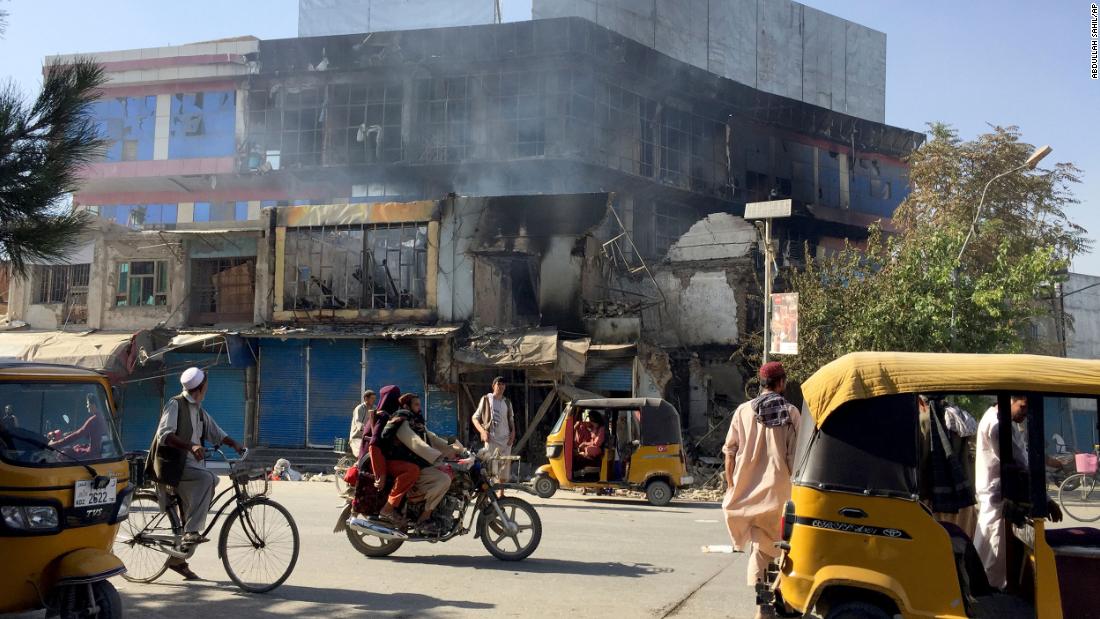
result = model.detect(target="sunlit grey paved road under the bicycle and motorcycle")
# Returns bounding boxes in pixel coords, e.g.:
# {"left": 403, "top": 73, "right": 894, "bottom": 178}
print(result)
{"left": 90, "top": 483, "right": 755, "bottom": 619}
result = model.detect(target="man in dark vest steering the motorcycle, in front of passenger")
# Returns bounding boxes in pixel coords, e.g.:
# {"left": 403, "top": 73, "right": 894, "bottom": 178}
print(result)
{"left": 381, "top": 394, "right": 460, "bottom": 532}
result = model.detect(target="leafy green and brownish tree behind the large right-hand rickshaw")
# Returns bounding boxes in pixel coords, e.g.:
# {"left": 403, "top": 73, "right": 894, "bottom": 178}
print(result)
{"left": 784, "top": 124, "right": 1089, "bottom": 379}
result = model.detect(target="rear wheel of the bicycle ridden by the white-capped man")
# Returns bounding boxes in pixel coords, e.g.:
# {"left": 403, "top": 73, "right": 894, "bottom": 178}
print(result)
{"left": 113, "top": 491, "right": 174, "bottom": 583}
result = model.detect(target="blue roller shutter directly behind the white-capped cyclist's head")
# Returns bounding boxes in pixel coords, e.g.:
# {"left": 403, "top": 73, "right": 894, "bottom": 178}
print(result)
{"left": 164, "top": 353, "right": 246, "bottom": 443}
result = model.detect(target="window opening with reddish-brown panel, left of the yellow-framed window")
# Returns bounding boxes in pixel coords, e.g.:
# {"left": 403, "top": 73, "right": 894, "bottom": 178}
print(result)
{"left": 190, "top": 257, "right": 256, "bottom": 324}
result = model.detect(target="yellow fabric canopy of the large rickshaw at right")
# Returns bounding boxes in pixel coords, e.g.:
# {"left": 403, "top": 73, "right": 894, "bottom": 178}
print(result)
{"left": 802, "top": 352, "right": 1100, "bottom": 428}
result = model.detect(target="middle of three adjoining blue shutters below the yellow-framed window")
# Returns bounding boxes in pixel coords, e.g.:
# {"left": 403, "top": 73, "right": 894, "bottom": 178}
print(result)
{"left": 308, "top": 340, "right": 363, "bottom": 447}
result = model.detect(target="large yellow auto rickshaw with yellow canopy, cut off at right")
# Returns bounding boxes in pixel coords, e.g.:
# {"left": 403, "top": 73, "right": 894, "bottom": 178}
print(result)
{"left": 757, "top": 353, "right": 1100, "bottom": 619}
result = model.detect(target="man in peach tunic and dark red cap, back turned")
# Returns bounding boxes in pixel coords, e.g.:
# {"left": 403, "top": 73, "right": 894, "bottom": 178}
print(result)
{"left": 722, "top": 362, "right": 800, "bottom": 617}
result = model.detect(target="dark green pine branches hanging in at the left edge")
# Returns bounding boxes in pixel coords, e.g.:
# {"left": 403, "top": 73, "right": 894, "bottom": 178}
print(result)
{"left": 0, "top": 59, "right": 106, "bottom": 275}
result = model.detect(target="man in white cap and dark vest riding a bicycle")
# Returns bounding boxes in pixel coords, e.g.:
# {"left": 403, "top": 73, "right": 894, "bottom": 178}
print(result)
{"left": 156, "top": 367, "right": 244, "bottom": 581}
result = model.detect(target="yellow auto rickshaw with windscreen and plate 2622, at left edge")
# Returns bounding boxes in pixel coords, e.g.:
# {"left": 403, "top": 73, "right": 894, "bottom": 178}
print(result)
{"left": 0, "top": 363, "right": 131, "bottom": 618}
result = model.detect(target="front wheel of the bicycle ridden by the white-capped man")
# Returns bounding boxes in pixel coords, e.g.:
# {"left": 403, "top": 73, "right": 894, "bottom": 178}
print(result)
{"left": 218, "top": 498, "right": 299, "bottom": 594}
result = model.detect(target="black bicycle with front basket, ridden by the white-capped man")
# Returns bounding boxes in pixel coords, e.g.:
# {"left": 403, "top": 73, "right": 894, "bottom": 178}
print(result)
{"left": 114, "top": 450, "right": 300, "bottom": 594}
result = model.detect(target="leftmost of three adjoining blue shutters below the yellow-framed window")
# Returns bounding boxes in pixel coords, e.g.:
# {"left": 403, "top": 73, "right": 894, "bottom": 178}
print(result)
{"left": 259, "top": 339, "right": 308, "bottom": 447}
